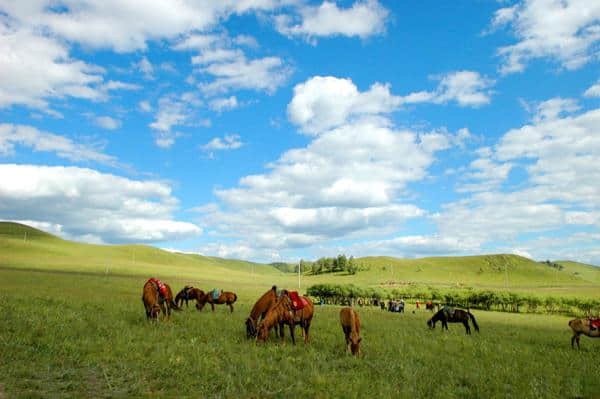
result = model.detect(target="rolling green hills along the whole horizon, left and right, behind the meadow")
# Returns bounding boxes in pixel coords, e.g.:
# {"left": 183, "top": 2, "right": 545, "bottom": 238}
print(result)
{"left": 0, "top": 222, "right": 600, "bottom": 296}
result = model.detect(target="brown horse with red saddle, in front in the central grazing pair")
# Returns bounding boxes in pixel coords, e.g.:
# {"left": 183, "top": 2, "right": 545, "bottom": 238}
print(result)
{"left": 256, "top": 290, "right": 314, "bottom": 345}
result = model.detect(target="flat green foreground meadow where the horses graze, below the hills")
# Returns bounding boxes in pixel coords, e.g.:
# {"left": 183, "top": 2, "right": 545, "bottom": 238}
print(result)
{"left": 0, "top": 269, "right": 600, "bottom": 398}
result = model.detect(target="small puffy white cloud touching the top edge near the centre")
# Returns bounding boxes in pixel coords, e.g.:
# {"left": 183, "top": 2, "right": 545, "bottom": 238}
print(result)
{"left": 275, "top": 0, "right": 389, "bottom": 40}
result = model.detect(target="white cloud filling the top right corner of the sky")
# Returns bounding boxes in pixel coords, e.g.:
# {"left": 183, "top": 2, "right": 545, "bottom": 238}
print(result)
{"left": 492, "top": 0, "right": 600, "bottom": 73}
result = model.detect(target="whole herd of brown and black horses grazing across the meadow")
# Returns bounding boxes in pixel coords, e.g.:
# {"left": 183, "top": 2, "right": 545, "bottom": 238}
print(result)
{"left": 142, "top": 279, "right": 600, "bottom": 355}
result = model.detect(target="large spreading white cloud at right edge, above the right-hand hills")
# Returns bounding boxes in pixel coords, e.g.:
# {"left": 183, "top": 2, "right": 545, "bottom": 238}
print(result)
{"left": 432, "top": 99, "right": 600, "bottom": 259}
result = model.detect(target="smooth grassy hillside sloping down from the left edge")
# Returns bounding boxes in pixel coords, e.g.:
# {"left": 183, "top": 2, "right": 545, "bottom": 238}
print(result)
{"left": 0, "top": 222, "right": 282, "bottom": 281}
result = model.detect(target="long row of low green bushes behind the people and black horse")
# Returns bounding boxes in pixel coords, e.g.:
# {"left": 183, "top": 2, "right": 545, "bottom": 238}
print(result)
{"left": 307, "top": 284, "right": 600, "bottom": 316}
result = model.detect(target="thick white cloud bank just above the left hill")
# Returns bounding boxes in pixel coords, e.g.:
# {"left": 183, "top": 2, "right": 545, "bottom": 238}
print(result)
{"left": 0, "top": 164, "right": 202, "bottom": 242}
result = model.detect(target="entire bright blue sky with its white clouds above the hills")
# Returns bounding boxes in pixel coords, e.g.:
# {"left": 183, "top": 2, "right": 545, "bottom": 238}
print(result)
{"left": 0, "top": 0, "right": 600, "bottom": 264}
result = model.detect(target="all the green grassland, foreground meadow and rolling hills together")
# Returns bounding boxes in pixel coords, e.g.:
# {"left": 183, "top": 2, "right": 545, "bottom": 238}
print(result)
{"left": 0, "top": 223, "right": 600, "bottom": 398}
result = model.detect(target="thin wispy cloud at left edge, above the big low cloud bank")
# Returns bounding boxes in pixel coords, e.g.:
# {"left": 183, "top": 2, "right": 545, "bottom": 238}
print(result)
{"left": 0, "top": 123, "right": 120, "bottom": 167}
